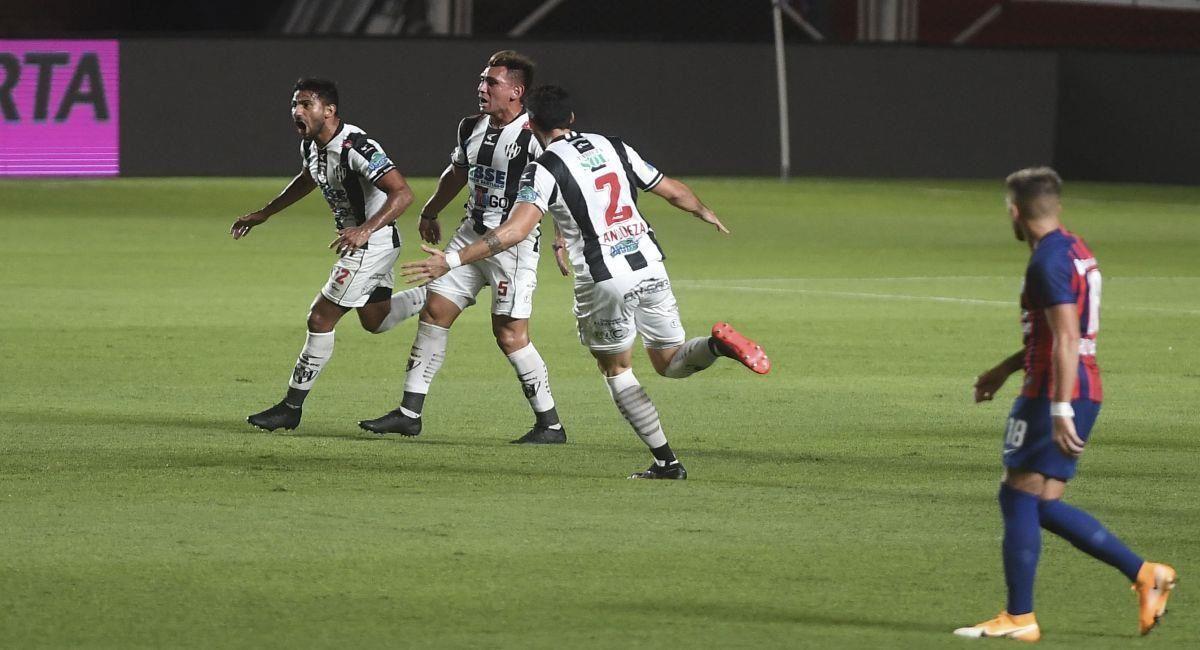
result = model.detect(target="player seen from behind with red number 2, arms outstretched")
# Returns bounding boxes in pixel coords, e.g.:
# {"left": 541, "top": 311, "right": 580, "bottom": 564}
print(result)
{"left": 393, "top": 86, "right": 770, "bottom": 479}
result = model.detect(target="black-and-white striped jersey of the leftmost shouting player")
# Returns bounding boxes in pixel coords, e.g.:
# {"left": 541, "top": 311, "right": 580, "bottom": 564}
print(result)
{"left": 300, "top": 122, "right": 400, "bottom": 248}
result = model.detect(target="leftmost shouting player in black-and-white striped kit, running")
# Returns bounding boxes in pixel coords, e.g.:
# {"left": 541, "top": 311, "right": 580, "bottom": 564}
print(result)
{"left": 229, "top": 78, "right": 425, "bottom": 431}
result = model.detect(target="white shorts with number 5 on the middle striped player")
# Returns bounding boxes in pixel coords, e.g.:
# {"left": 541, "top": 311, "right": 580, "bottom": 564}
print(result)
{"left": 428, "top": 222, "right": 539, "bottom": 319}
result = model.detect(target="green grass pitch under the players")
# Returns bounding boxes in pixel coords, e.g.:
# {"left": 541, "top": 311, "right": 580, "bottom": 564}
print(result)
{"left": 0, "top": 179, "right": 1200, "bottom": 649}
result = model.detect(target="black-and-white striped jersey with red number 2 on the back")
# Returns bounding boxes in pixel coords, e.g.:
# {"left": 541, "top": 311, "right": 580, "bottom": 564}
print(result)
{"left": 516, "top": 131, "right": 664, "bottom": 282}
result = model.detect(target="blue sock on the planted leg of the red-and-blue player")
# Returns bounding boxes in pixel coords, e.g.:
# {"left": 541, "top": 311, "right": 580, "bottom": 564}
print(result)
{"left": 1000, "top": 485, "right": 1042, "bottom": 615}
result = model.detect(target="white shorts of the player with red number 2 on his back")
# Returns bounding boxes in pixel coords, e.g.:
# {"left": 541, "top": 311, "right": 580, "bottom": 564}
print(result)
{"left": 575, "top": 263, "right": 684, "bottom": 353}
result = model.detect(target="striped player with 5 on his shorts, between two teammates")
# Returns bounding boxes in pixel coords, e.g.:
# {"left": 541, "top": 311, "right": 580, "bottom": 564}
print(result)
{"left": 359, "top": 50, "right": 568, "bottom": 444}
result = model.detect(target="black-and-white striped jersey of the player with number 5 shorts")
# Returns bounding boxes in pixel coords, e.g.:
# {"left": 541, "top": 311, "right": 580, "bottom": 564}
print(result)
{"left": 450, "top": 110, "right": 541, "bottom": 235}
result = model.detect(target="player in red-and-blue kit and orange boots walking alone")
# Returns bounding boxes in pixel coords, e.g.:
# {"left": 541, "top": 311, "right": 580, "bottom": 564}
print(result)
{"left": 954, "top": 167, "right": 1175, "bottom": 642}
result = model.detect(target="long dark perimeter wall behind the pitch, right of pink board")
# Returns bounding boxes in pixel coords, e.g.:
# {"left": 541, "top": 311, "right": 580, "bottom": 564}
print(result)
{"left": 120, "top": 38, "right": 1200, "bottom": 183}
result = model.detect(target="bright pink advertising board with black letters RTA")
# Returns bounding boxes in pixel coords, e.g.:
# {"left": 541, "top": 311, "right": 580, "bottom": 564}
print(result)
{"left": 0, "top": 40, "right": 120, "bottom": 176}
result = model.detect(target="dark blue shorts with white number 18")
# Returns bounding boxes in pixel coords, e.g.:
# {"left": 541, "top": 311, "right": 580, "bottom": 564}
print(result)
{"left": 1003, "top": 396, "right": 1100, "bottom": 481}
